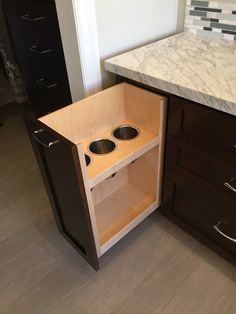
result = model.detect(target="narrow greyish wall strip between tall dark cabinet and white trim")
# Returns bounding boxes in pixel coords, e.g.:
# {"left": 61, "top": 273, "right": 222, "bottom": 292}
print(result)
{"left": 56, "top": 0, "right": 84, "bottom": 102}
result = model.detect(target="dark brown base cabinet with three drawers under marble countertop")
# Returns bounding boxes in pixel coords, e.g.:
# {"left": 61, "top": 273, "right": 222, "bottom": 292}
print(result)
{"left": 161, "top": 96, "right": 236, "bottom": 264}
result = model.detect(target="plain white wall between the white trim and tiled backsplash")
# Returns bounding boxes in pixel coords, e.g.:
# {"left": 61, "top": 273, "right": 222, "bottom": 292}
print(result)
{"left": 95, "top": 0, "right": 182, "bottom": 87}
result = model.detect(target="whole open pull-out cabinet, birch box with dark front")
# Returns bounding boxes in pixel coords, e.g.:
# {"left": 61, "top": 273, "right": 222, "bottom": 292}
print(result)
{"left": 26, "top": 83, "right": 166, "bottom": 269}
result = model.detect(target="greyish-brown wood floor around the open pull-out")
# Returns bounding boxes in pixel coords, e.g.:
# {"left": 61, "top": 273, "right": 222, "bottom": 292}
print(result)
{"left": 0, "top": 116, "right": 236, "bottom": 314}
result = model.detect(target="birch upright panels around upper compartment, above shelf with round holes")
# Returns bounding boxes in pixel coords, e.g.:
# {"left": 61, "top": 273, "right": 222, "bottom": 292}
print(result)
{"left": 39, "top": 83, "right": 164, "bottom": 144}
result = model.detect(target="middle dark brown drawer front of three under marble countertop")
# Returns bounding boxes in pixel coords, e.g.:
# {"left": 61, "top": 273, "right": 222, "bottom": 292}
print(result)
{"left": 166, "top": 138, "right": 236, "bottom": 203}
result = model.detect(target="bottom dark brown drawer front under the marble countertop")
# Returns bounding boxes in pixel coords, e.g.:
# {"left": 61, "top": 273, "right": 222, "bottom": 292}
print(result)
{"left": 162, "top": 171, "right": 236, "bottom": 262}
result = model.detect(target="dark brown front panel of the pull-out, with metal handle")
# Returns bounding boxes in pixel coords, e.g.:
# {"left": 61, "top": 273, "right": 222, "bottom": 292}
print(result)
{"left": 24, "top": 116, "right": 99, "bottom": 270}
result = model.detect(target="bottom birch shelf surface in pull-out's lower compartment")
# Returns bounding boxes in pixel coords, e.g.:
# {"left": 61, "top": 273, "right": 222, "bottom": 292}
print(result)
{"left": 95, "top": 183, "right": 155, "bottom": 246}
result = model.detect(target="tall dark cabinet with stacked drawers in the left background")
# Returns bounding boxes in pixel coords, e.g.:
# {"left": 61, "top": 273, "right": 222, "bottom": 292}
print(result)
{"left": 3, "top": 0, "right": 72, "bottom": 117}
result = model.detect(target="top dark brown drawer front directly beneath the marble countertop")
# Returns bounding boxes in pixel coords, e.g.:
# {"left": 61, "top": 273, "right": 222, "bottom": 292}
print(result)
{"left": 168, "top": 96, "right": 236, "bottom": 163}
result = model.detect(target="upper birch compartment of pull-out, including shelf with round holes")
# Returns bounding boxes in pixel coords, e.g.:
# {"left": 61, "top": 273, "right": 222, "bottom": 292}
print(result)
{"left": 40, "top": 83, "right": 164, "bottom": 188}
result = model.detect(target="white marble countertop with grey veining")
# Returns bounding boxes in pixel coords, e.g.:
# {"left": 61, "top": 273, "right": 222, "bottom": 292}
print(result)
{"left": 105, "top": 33, "right": 236, "bottom": 116}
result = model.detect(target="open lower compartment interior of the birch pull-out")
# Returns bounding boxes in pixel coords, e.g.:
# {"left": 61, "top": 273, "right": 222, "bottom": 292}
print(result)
{"left": 92, "top": 147, "right": 158, "bottom": 246}
